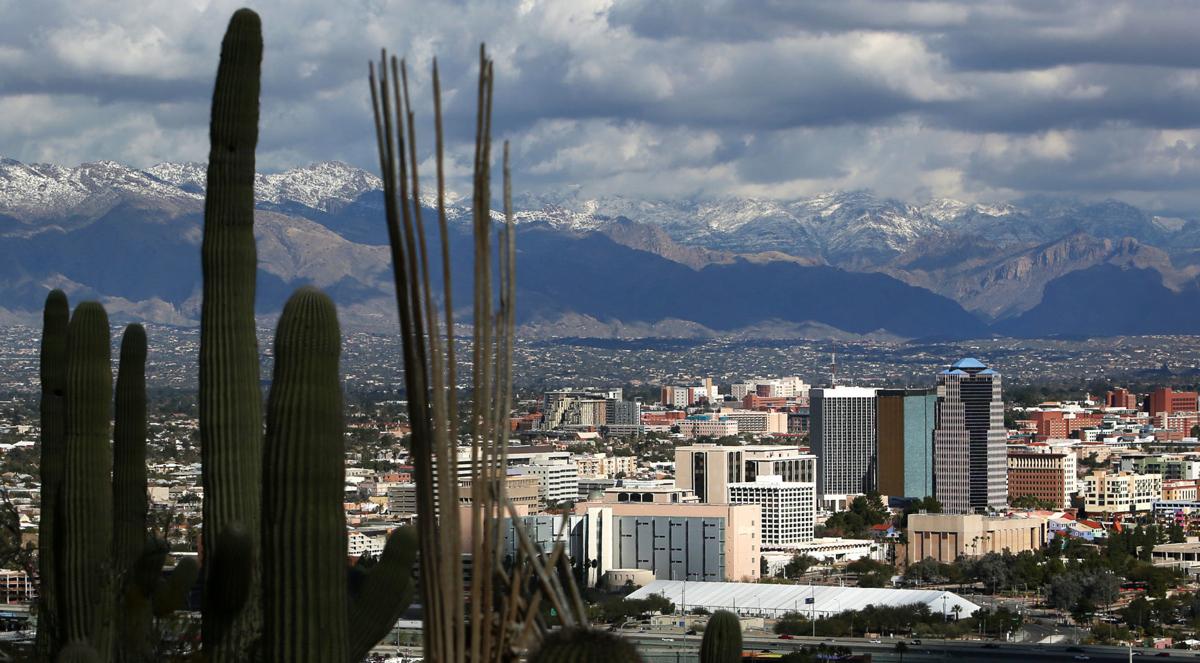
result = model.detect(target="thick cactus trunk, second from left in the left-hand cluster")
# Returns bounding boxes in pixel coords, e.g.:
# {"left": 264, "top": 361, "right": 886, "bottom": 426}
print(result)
{"left": 59, "top": 301, "right": 114, "bottom": 658}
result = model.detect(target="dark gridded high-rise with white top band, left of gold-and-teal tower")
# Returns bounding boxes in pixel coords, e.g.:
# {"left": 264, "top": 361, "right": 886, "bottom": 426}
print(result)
{"left": 809, "top": 387, "right": 877, "bottom": 500}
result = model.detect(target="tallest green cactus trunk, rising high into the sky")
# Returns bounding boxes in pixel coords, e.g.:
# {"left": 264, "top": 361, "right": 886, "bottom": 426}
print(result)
{"left": 199, "top": 10, "right": 263, "bottom": 663}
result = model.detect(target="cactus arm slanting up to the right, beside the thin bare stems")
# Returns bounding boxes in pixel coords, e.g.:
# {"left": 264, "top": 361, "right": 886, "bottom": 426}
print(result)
{"left": 347, "top": 527, "right": 416, "bottom": 663}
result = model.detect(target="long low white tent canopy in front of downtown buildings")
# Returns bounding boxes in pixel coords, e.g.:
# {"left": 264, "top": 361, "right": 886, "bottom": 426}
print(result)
{"left": 629, "top": 580, "right": 979, "bottom": 619}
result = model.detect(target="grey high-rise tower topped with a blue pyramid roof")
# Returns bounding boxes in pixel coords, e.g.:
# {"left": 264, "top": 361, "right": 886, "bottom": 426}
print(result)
{"left": 934, "top": 358, "right": 1008, "bottom": 513}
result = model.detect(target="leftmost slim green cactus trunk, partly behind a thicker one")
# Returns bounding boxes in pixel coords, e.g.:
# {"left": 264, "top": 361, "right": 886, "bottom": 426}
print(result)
{"left": 36, "top": 289, "right": 71, "bottom": 661}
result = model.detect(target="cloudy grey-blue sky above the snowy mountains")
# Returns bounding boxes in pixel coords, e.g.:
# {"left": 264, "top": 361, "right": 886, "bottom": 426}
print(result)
{"left": 0, "top": 0, "right": 1200, "bottom": 216}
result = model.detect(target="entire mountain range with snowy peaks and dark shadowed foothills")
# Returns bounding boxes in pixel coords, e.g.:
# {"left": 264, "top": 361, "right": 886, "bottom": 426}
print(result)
{"left": 0, "top": 159, "right": 1200, "bottom": 339}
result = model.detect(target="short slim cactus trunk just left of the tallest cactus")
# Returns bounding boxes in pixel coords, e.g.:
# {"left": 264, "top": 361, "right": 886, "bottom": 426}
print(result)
{"left": 113, "top": 324, "right": 147, "bottom": 574}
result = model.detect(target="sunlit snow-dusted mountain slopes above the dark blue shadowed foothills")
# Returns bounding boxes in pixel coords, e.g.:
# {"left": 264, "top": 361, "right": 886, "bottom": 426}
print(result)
{"left": 0, "top": 160, "right": 1200, "bottom": 336}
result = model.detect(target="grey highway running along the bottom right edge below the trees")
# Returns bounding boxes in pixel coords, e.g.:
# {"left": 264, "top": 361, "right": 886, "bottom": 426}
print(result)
{"left": 624, "top": 633, "right": 1200, "bottom": 663}
